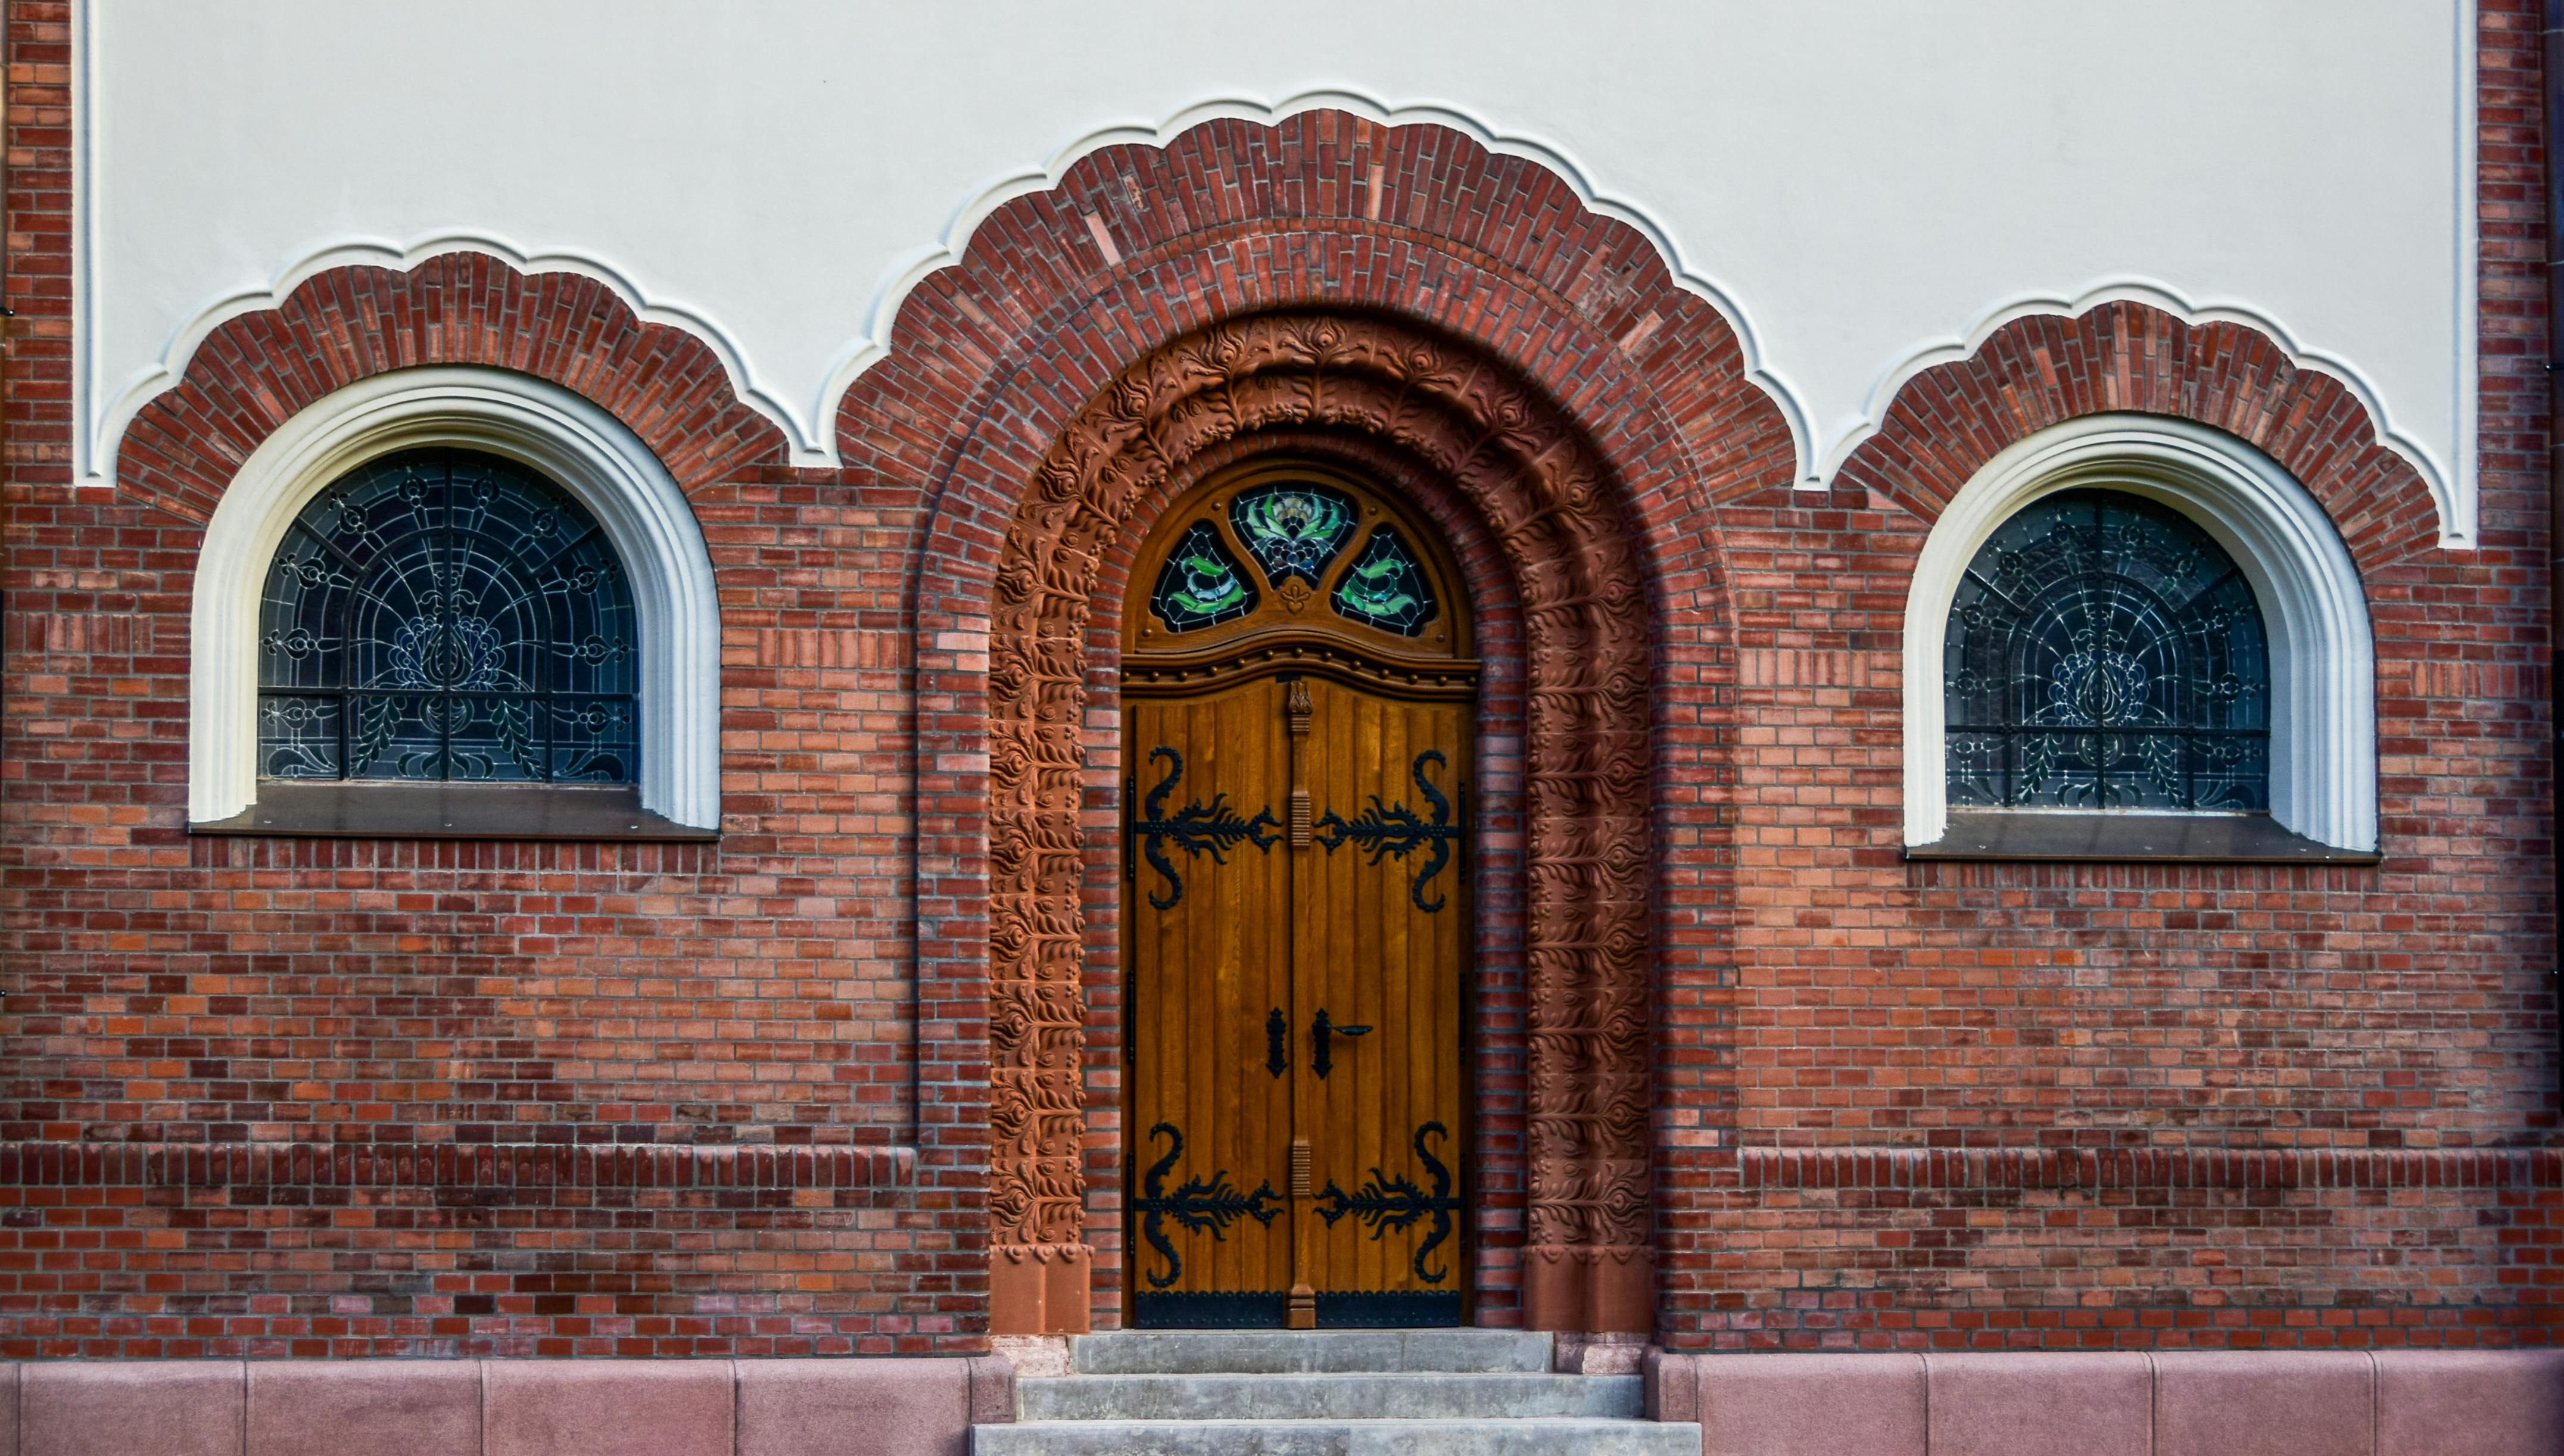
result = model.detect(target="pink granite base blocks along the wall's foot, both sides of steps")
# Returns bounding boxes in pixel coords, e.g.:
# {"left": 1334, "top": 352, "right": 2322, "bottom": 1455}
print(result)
{"left": 0, "top": 1351, "right": 2564, "bottom": 1456}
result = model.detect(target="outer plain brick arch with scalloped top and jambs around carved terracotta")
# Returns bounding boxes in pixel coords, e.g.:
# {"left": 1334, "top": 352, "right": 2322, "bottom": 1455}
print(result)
{"left": 839, "top": 110, "right": 1795, "bottom": 1333}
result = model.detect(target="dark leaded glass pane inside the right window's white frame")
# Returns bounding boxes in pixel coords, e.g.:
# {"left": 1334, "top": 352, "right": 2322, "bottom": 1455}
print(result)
{"left": 1943, "top": 490, "right": 2269, "bottom": 813}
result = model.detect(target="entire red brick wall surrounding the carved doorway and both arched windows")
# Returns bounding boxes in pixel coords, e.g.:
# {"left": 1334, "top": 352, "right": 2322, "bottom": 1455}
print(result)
{"left": 0, "top": 0, "right": 2564, "bottom": 1356}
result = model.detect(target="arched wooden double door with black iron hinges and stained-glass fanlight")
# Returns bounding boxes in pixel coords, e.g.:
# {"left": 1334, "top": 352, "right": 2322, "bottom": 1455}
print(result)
{"left": 1123, "top": 459, "right": 1477, "bottom": 1328}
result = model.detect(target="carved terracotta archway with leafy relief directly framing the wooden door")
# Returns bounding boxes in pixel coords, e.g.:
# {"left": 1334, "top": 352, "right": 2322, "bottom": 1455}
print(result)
{"left": 987, "top": 313, "right": 1654, "bottom": 1333}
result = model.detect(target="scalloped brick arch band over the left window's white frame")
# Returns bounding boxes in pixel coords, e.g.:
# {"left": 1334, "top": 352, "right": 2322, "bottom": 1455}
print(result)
{"left": 116, "top": 254, "right": 787, "bottom": 520}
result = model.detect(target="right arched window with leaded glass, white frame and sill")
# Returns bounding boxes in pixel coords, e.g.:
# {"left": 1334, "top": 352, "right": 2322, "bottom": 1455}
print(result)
{"left": 1905, "top": 413, "right": 2377, "bottom": 861}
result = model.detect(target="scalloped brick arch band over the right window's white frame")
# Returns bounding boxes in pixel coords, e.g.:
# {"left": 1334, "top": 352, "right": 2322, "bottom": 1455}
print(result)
{"left": 1836, "top": 303, "right": 2438, "bottom": 572}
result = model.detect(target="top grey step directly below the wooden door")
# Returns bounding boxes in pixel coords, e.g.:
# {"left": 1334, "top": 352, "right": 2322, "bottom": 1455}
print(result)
{"left": 1069, "top": 1330, "right": 1552, "bottom": 1374}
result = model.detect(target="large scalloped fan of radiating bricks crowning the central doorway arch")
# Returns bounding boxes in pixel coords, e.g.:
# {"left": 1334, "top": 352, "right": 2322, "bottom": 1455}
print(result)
{"left": 836, "top": 110, "right": 1795, "bottom": 538}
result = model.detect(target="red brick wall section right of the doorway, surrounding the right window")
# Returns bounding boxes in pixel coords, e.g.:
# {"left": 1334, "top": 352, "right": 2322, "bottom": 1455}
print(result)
{"left": 1659, "top": 5, "right": 2564, "bottom": 1348}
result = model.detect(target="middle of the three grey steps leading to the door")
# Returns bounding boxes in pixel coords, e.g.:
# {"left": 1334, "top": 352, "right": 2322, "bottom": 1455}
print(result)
{"left": 1015, "top": 1371, "right": 1646, "bottom": 1420}
